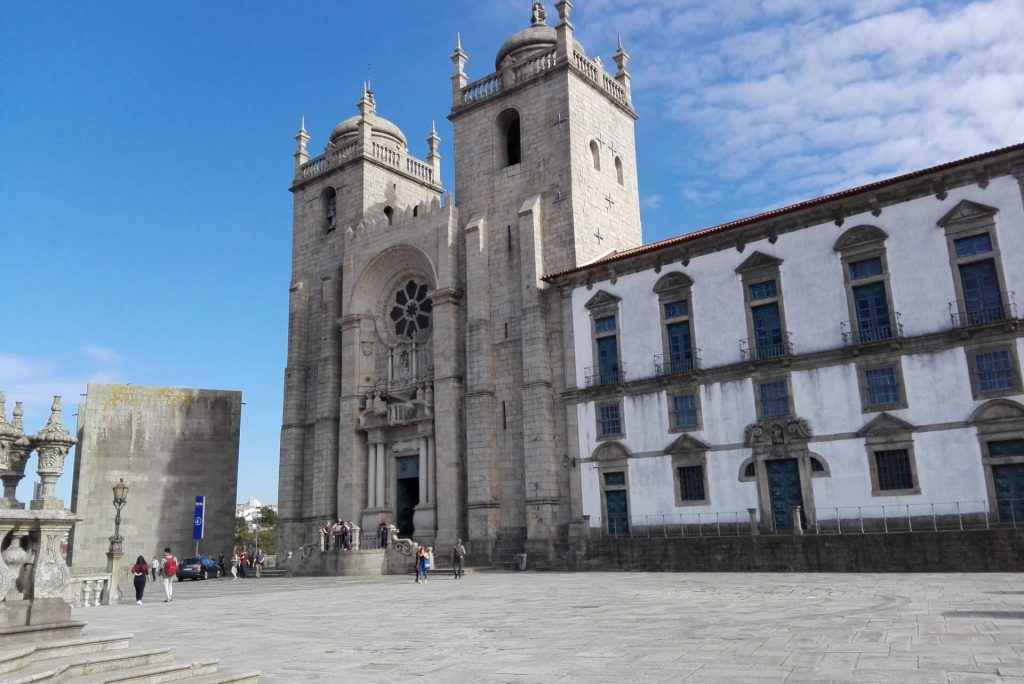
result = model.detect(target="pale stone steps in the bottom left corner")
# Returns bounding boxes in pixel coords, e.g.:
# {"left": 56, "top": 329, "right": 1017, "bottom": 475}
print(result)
{"left": 0, "top": 622, "right": 259, "bottom": 684}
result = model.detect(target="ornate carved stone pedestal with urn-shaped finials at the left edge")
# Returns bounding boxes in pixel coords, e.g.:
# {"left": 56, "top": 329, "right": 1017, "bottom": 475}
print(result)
{"left": 0, "top": 392, "right": 79, "bottom": 628}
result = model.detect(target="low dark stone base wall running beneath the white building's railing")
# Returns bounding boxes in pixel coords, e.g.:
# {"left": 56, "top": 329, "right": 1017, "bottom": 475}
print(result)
{"left": 552, "top": 528, "right": 1024, "bottom": 572}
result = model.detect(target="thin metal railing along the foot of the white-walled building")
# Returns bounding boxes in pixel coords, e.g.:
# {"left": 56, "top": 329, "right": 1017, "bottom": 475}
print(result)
{"left": 589, "top": 499, "right": 1024, "bottom": 539}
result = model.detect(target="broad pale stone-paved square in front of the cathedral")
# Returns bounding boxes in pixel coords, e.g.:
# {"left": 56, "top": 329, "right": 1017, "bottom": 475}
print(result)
{"left": 76, "top": 572, "right": 1024, "bottom": 684}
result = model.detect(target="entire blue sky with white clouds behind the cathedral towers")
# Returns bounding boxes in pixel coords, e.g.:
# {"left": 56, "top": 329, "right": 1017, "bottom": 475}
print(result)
{"left": 0, "top": 0, "right": 1024, "bottom": 502}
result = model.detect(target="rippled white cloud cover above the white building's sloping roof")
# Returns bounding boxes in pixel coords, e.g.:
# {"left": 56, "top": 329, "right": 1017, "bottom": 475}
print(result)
{"left": 577, "top": 0, "right": 1024, "bottom": 214}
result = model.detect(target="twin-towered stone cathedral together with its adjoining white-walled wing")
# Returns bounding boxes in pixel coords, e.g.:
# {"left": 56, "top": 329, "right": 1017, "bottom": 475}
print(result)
{"left": 279, "top": 0, "right": 1024, "bottom": 566}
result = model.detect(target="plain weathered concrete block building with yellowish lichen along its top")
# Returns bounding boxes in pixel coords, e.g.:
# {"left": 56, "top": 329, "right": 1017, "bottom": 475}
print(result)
{"left": 69, "top": 383, "right": 242, "bottom": 571}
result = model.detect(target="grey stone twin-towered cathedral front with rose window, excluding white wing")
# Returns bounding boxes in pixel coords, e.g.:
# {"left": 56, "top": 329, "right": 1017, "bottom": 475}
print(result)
{"left": 279, "top": 0, "right": 641, "bottom": 558}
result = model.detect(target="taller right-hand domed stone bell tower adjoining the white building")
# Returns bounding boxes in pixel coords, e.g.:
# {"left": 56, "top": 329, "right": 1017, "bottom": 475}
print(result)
{"left": 449, "top": 0, "right": 641, "bottom": 562}
